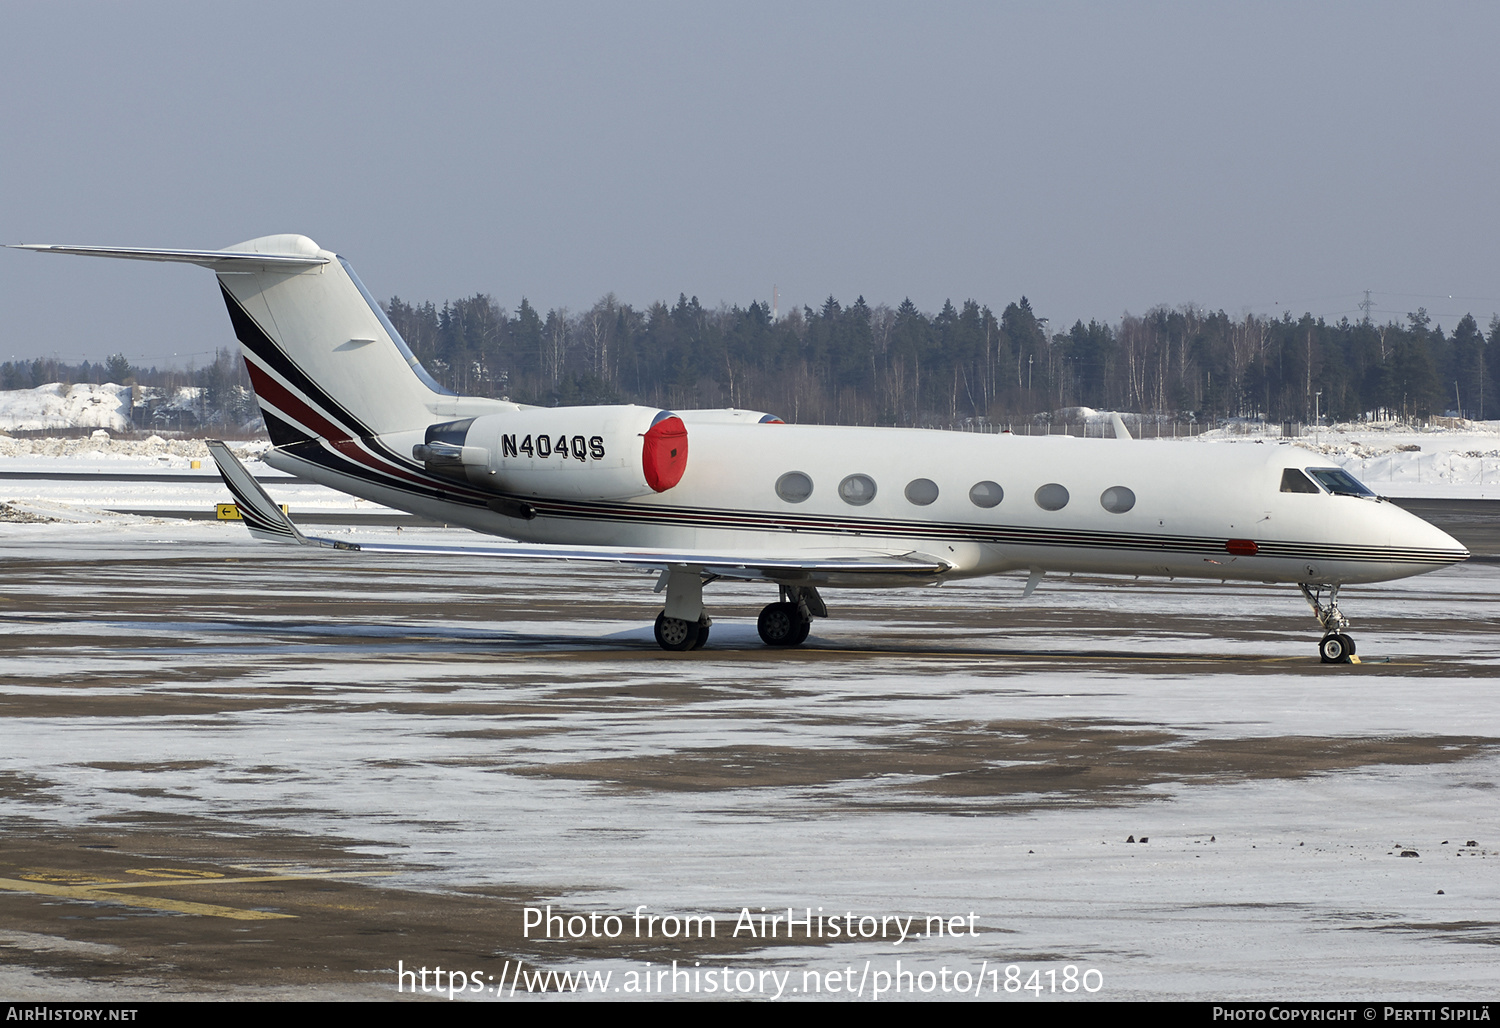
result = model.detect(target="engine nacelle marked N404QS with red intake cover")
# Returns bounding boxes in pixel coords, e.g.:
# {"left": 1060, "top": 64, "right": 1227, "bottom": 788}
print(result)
{"left": 411, "top": 404, "right": 687, "bottom": 500}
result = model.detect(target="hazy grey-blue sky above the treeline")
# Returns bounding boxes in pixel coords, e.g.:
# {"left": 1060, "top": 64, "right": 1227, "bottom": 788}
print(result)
{"left": 0, "top": 0, "right": 1500, "bottom": 366}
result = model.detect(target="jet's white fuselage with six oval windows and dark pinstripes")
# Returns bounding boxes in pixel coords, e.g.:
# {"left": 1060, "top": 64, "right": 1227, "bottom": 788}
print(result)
{"left": 267, "top": 413, "right": 1467, "bottom": 585}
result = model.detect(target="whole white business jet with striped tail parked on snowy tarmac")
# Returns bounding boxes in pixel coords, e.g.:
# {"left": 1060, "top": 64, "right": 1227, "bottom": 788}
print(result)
{"left": 8, "top": 236, "right": 1469, "bottom": 663}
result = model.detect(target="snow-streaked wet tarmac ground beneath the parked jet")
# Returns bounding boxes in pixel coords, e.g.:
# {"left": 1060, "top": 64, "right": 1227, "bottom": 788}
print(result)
{"left": 0, "top": 518, "right": 1500, "bottom": 1001}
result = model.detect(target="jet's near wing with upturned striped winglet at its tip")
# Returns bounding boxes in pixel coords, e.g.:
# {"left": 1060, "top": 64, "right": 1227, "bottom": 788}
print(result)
{"left": 209, "top": 440, "right": 951, "bottom": 584}
